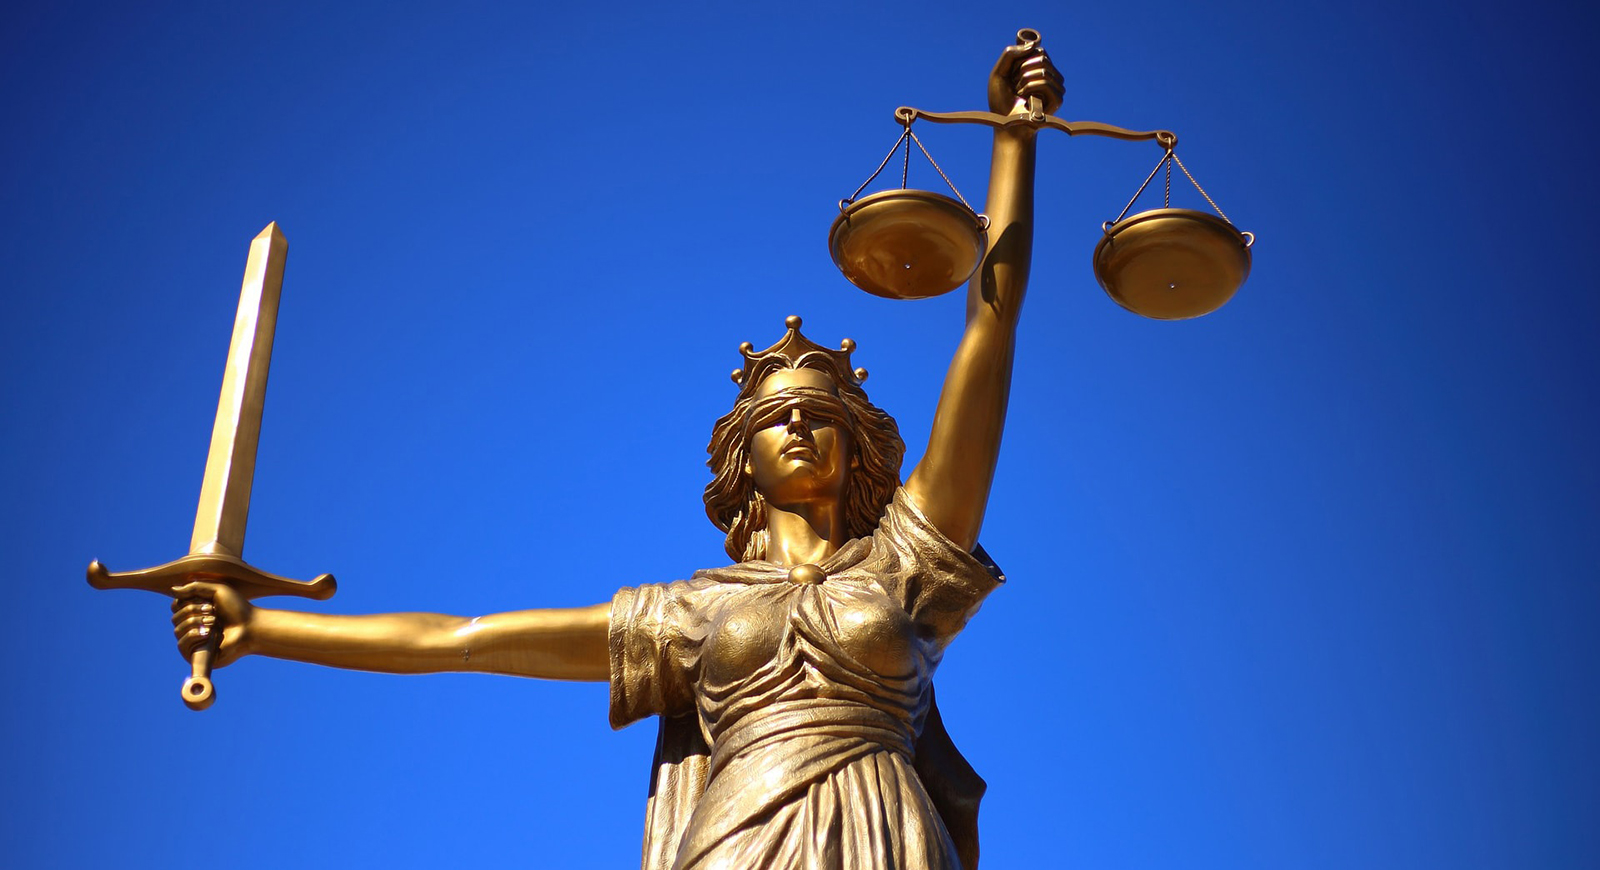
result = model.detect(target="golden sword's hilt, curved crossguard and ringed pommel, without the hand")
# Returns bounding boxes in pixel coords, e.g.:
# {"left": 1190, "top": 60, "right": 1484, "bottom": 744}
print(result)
{"left": 88, "top": 553, "right": 338, "bottom": 710}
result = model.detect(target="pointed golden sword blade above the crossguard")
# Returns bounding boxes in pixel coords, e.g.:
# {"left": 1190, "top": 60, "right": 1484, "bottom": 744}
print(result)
{"left": 189, "top": 222, "right": 290, "bottom": 557}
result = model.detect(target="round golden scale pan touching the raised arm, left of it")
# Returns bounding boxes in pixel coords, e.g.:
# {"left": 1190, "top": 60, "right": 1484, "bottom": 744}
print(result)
{"left": 827, "top": 190, "right": 989, "bottom": 299}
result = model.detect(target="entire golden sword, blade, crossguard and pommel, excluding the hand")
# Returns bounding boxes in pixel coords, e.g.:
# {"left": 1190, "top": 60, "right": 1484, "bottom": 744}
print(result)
{"left": 88, "top": 222, "right": 334, "bottom": 710}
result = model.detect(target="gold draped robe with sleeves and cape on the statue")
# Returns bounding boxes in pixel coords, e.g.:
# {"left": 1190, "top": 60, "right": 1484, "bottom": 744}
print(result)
{"left": 610, "top": 489, "right": 1003, "bottom": 870}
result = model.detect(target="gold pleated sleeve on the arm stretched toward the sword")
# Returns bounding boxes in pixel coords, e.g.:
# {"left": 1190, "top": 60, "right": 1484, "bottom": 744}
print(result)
{"left": 608, "top": 579, "right": 718, "bottom": 728}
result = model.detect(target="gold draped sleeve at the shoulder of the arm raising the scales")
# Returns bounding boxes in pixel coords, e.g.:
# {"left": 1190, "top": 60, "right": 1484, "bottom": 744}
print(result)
{"left": 862, "top": 489, "right": 1005, "bottom": 646}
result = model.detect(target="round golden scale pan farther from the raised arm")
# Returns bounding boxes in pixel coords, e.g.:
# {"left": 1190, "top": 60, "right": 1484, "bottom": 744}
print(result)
{"left": 1094, "top": 208, "right": 1254, "bottom": 320}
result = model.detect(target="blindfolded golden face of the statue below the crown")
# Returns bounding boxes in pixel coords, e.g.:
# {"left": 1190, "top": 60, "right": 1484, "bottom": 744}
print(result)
{"left": 746, "top": 368, "right": 854, "bottom": 507}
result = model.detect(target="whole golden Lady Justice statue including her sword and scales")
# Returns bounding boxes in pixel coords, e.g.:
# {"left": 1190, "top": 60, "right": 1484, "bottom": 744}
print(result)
{"left": 90, "top": 30, "right": 1253, "bottom": 870}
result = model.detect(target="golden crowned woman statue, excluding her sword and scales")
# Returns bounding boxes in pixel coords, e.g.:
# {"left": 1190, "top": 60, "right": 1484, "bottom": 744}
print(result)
{"left": 156, "top": 33, "right": 1062, "bottom": 870}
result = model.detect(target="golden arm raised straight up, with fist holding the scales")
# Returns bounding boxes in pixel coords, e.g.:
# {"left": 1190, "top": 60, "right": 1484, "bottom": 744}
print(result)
{"left": 906, "top": 43, "right": 1062, "bottom": 549}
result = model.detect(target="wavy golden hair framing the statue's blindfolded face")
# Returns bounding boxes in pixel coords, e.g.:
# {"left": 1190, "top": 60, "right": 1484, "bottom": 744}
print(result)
{"left": 706, "top": 366, "right": 906, "bottom": 561}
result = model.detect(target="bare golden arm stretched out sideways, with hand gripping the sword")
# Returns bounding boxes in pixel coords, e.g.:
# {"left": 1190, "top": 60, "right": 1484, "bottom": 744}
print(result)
{"left": 173, "top": 582, "right": 610, "bottom": 681}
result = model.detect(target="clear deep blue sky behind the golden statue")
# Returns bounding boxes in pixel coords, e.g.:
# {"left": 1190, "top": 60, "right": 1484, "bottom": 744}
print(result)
{"left": 0, "top": 0, "right": 1600, "bottom": 868}
